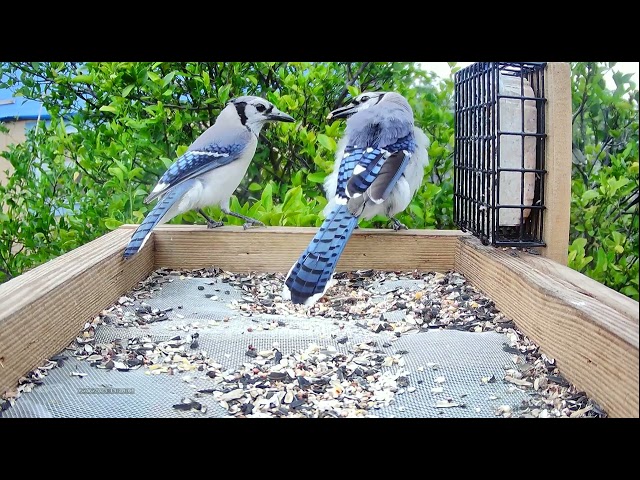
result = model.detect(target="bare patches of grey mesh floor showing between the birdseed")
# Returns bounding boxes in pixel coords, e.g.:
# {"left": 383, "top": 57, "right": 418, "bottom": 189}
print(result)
{"left": 2, "top": 278, "right": 532, "bottom": 418}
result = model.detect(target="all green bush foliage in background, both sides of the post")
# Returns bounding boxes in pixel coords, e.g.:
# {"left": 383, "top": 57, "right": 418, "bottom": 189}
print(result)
{"left": 0, "top": 62, "right": 638, "bottom": 300}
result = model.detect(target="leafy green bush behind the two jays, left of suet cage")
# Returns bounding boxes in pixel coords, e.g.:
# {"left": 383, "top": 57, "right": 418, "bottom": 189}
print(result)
{"left": 0, "top": 62, "right": 453, "bottom": 281}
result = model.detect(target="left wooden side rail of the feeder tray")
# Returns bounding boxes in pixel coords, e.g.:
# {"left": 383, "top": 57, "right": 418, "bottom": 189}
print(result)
{"left": 0, "top": 229, "right": 153, "bottom": 394}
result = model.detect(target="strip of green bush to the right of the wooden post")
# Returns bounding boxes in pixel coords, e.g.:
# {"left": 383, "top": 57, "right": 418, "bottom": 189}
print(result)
{"left": 569, "top": 63, "right": 638, "bottom": 300}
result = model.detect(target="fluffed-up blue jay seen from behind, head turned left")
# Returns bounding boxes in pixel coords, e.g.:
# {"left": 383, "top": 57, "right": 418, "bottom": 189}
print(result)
{"left": 283, "top": 92, "right": 430, "bottom": 306}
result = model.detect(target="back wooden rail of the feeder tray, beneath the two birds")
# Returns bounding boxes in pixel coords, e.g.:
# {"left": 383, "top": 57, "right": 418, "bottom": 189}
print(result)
{"left": 148, "top": 225, "right": 467, "bottom": 273}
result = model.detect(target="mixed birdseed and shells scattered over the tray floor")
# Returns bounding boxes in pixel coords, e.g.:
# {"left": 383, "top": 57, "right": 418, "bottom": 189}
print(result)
{"left": 0, "top": 268, "right": 606, "bottom": 418}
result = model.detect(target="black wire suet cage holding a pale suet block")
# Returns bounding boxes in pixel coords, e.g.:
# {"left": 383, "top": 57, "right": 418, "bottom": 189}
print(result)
{"left": 454, "top": 62, "right": 546, "bottom": 247}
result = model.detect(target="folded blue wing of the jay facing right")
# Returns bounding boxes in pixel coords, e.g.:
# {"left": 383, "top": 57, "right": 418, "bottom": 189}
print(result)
{"left": 144, "top": 143, "right": 245, "bottom": 203}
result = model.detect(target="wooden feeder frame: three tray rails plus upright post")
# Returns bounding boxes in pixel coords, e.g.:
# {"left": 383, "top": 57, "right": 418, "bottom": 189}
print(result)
{"left": 0, "top": 63, "right": 639, "bottom": 418}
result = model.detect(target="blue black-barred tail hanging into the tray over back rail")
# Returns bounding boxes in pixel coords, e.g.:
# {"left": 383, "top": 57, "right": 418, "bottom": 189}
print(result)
{"left": 285, "top": 205, "right": 358, "bottom": 303}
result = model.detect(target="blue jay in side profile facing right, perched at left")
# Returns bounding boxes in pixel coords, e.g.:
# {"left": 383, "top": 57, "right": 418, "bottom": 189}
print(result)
{"left": 124, "top": 96, "right": 294, "bottom": 258}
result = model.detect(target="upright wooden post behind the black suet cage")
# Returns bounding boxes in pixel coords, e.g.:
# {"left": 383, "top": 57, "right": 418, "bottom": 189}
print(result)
{"left": 541, "top": 62, "right": 572, "bottom": 265}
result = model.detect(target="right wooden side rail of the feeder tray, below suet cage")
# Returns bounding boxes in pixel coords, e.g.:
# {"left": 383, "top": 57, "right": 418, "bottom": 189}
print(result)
{"left": 455, "top": 238, "right": 639, "bottom": 418}
